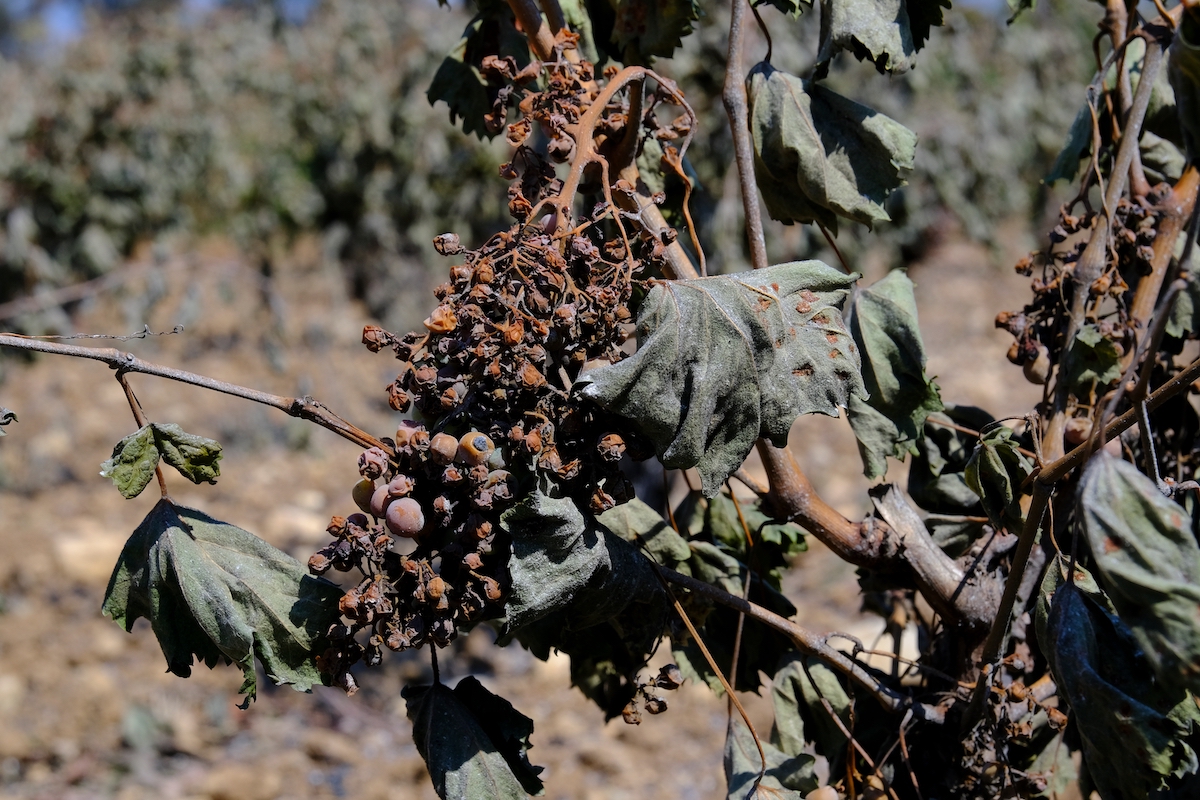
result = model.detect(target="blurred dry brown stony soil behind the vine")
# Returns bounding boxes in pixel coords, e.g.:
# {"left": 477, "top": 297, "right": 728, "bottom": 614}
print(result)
{"left": 0, "top": 232, "right": 1038, "bottom": 800}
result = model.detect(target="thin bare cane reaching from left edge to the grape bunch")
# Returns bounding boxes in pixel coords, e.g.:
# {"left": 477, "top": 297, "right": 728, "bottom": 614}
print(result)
{"left": 0, "top": 333, "right": 391, "bottom": 455}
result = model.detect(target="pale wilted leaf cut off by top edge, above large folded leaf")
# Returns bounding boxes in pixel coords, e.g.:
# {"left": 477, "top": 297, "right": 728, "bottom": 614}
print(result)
{"left": 817, "top": 0, "right": 950, "bottom": 74}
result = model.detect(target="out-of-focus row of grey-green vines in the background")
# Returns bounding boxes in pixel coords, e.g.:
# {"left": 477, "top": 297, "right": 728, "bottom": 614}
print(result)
{"left": 0, "top": 0, "right": 1100, "bottom": 333}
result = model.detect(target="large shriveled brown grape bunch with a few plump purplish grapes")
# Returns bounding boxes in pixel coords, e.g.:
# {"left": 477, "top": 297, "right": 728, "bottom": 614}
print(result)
{"left": 308, "top": 42, "right": 662, "bottom": 691}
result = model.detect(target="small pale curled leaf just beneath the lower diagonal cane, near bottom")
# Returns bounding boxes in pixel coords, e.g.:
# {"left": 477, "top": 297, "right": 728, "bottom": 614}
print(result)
{"left": 770, "top": 652, "right": 852, "bottom": 772}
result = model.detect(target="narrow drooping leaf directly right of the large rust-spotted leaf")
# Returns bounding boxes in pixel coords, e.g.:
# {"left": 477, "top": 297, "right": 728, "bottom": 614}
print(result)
{"left": 846, "top": 270, "right": 942, "bottom": 479}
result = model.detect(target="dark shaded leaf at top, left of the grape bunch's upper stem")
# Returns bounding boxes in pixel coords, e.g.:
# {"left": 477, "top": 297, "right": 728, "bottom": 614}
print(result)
{"left": 426, "top": 2, "right": 529, "bottom": 139}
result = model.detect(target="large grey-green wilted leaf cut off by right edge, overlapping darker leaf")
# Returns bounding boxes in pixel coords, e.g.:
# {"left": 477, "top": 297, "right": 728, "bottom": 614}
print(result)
{"left": 1078, "top": 456, "right": 1200, "bottom": 693}
